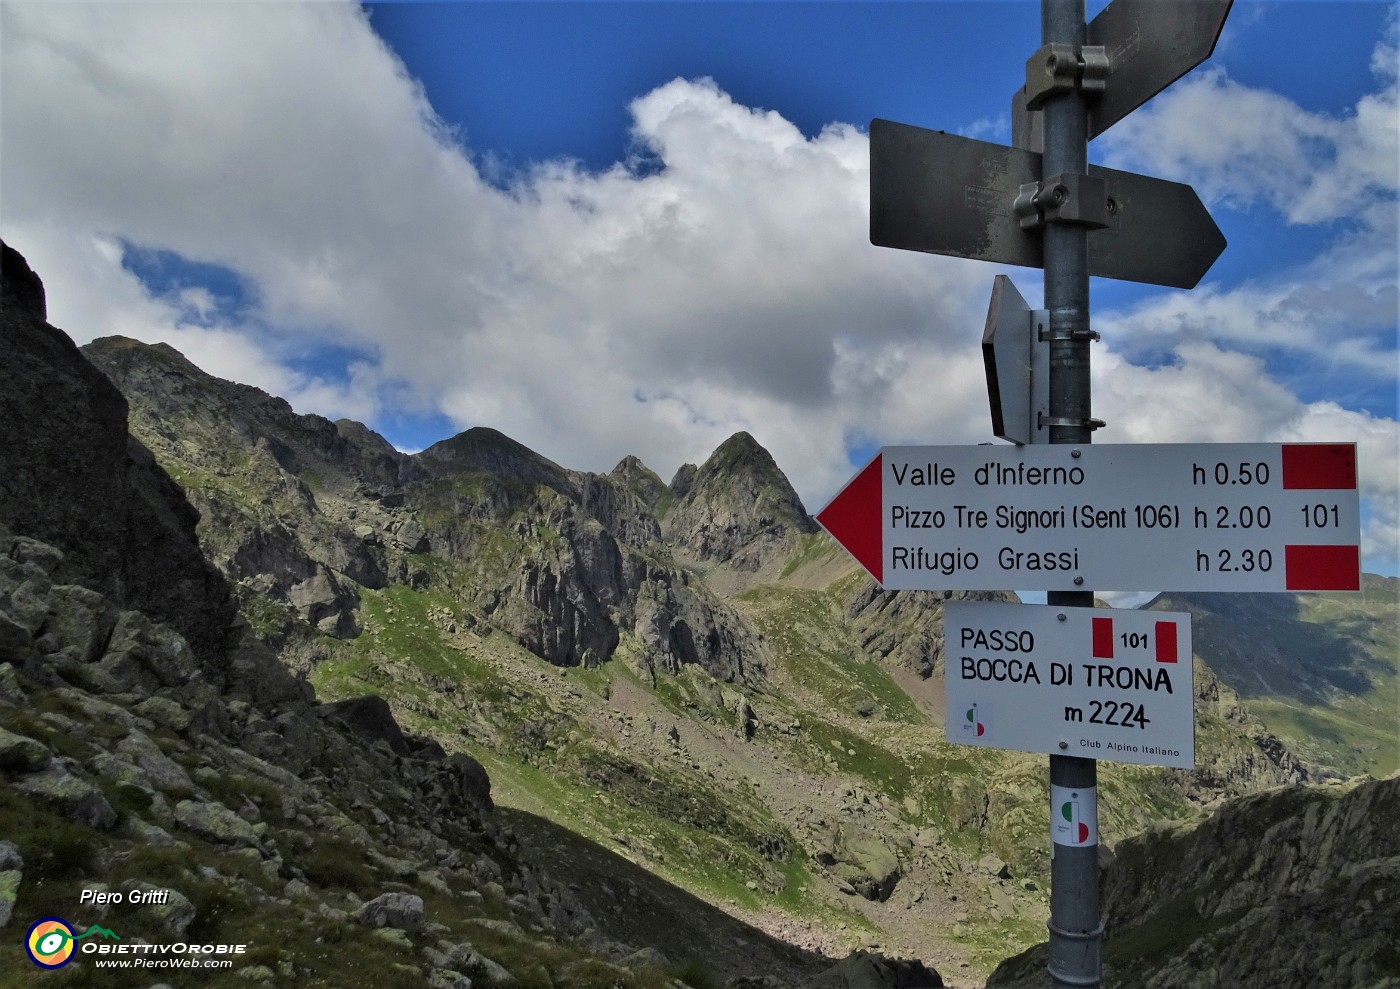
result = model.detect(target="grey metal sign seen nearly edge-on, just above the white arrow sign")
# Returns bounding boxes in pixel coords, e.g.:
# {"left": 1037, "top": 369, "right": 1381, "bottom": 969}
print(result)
{"left": 981, "top": 275, "right": 1050, "bottom": 445}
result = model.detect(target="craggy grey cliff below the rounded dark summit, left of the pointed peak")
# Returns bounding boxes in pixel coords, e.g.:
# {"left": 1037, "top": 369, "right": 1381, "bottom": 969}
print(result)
{"left": 407, "top": 427, "right": 764, "bottom": 681}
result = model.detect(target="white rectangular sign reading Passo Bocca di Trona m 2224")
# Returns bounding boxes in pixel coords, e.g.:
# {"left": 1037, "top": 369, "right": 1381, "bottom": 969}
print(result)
{"left": 944, "top": 601, "right": 1196, "bottom": 769}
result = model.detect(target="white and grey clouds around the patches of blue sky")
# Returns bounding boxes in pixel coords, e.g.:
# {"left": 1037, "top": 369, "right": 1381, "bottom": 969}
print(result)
{"left": 0, "top": 1, "right": 1396, "bottom": 571}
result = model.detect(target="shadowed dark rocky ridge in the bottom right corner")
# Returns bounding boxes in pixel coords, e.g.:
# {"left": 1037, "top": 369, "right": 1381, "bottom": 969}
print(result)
{"left": 988, "top": 776, "right": 1400, "bottom": 989}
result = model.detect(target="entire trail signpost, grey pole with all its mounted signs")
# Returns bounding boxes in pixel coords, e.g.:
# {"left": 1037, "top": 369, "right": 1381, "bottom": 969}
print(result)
{"left": 856, "top": 0, "right": 1359, "bottom": 989}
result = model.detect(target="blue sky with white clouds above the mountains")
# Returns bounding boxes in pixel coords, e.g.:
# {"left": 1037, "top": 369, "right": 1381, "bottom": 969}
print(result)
{"left": 0, "top": 0, "right": 1400, "bottom": 573}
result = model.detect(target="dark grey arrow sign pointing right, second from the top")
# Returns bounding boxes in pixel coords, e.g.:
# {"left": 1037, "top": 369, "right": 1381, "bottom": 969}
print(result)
{"left": 871, "top": 119, "right": 1225, "bottom": 289}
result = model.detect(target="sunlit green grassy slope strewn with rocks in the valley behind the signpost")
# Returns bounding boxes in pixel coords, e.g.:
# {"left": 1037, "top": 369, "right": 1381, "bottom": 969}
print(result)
{"left": 314, "top": 548, "right": 1271, "bottom": 975}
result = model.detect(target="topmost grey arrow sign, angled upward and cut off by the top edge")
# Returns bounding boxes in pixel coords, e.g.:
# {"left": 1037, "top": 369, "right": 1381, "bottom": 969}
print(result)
{"left": 1011, "top": 0, "right": 1235, "bottom": 145}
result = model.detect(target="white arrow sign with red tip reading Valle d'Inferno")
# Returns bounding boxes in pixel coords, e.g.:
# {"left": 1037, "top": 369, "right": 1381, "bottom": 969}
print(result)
{"left": 816, "top": 443, "right": 1361, "bottom": 591}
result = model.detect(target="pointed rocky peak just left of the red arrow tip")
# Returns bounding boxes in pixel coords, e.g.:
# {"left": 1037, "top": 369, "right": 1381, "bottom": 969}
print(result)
{"left": 662, "top": 431, "right": 818, "bottom": 573}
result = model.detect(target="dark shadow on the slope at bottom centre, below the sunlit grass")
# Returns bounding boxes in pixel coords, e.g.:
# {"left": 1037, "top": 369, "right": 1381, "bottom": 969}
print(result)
{"left": 496, "top": 807, "right": 836, "bottom": 983}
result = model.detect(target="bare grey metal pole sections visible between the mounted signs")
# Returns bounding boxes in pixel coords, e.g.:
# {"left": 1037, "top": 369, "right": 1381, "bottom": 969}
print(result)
{"left": 1040, "top": 0, "right": 1103, "bottom": 989}
